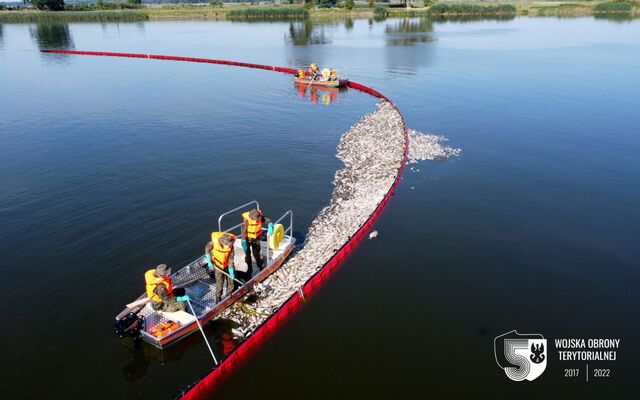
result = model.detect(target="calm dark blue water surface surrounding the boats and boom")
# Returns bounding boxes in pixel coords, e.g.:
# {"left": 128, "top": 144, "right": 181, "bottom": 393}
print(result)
{"left": 0, "top": 18, "right": 640, "bottom": 399}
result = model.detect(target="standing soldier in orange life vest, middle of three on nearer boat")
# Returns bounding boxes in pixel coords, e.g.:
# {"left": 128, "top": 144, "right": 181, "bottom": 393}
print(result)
{"left": 204, "top": 232, "right": 236, "bottom": 302}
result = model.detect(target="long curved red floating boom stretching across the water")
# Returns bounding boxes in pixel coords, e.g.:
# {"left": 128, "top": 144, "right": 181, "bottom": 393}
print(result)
{"left": 42, "top": 50, "right": 409, "bottom": 399}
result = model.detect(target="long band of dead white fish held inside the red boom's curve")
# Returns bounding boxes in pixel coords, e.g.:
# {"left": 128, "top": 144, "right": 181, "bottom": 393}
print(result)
{"left": 221, "top": 102, "right": 406, "bottom": 331}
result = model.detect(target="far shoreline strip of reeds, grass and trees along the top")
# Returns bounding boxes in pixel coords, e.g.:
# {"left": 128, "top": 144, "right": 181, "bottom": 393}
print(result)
{"left": 0, "top": 0, "right": 640, "bottom": 23}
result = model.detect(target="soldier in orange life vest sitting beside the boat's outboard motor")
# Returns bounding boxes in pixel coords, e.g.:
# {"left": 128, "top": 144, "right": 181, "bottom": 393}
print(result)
{"left": 144, "top": 264, "right": 189, "bottom": 312}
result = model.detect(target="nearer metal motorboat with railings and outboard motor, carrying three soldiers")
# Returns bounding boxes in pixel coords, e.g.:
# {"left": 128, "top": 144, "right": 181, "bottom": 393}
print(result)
{"left": 115, "top": 201, "right": 296, "bottom": 349}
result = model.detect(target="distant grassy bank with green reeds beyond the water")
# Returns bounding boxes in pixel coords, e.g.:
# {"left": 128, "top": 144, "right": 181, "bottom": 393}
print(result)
{"left": 0, "top": 0, "right": 640, "bottom": 22}
